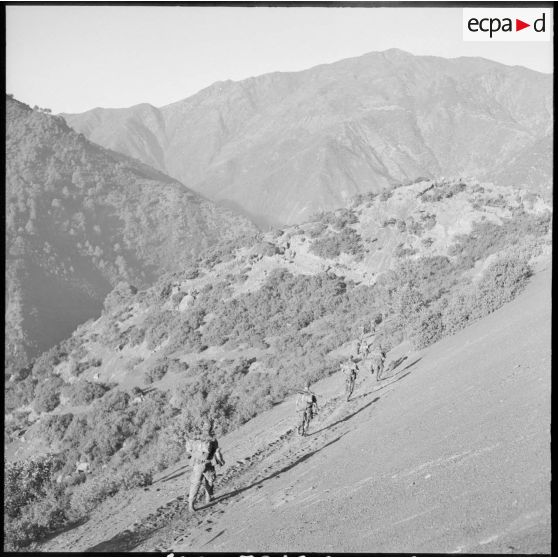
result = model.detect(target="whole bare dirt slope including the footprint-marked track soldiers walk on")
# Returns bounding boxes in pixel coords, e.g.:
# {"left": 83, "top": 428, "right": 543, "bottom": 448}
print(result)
{"left": 41, "top": 269, "right": 551, "bottom": 554}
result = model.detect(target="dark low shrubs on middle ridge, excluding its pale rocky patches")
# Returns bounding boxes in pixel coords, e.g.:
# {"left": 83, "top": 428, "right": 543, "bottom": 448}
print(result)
{"left": 5, "top": 185, "right": 551, "bottom": 550}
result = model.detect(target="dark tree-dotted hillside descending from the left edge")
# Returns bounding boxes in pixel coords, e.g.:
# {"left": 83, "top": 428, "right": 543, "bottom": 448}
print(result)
{"left": 6, "top": 98, "right": 255, "bottom": 372}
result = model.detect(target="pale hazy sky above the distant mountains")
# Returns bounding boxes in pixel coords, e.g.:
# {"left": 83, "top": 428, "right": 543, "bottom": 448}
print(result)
{"left": 6, "top": 5, "right": 553, "bottom": 112}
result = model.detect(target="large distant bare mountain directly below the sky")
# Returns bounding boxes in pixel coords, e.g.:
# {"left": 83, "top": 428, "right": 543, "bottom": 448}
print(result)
{"left": 65, "top": 49, "right": 553, "bottom": 224}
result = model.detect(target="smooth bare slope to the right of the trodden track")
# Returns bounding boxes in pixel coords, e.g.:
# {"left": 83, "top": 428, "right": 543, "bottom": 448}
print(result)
{"left": 173, "top": 270, "right": 550, "bottom": 554}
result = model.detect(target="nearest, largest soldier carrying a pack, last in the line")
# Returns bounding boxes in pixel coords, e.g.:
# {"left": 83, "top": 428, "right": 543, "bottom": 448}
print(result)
{"left": 186, "top": 421, "right": 225, "bottom": 512}
